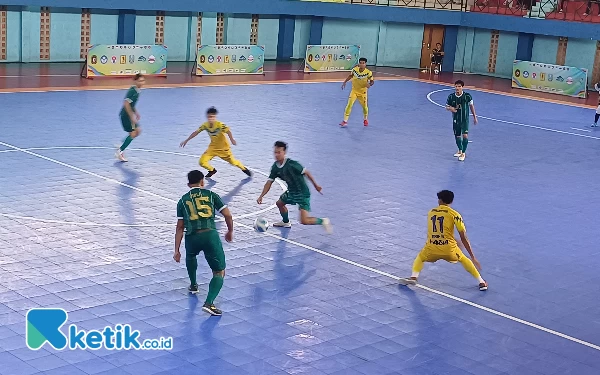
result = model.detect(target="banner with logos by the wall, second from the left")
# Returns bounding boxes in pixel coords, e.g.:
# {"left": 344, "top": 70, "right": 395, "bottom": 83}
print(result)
{"left": 196, "top": 45, "right": 265, "bottom": 76}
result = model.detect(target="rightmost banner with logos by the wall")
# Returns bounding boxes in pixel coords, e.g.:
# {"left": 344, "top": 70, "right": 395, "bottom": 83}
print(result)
{"left": 512, "top": 61, "right": 588, "bottom": 98}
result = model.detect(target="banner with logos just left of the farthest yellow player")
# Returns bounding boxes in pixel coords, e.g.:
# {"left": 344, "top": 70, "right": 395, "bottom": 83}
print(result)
{"left": 304, "top": 45, "right": 360, "bottom": 73}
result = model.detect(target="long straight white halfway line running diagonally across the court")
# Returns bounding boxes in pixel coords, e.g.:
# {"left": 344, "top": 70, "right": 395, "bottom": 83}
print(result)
{"left": 0, "top": 141, "right": 600, "bottom": 351}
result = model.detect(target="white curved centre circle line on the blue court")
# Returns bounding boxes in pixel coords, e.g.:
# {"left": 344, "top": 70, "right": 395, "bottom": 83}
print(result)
{"left": 0, "top": 142, "right": 287, "bottom": 228}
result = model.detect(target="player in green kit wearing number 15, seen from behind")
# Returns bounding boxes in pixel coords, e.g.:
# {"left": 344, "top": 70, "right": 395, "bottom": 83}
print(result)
{"left": 173, "top": 171, "right": 233, "bottom": 315}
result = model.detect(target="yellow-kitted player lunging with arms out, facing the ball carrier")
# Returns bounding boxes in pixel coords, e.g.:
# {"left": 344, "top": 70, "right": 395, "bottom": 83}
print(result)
{"left": 180, "top": 107, "right": 252, "bottom": 178}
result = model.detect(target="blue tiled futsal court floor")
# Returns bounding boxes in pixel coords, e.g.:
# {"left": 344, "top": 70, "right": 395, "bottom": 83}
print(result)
{"left": 0, "top": 80, "right": 600, "bottom": 375}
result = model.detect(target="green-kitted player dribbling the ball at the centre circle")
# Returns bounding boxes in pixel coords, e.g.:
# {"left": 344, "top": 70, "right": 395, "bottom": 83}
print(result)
{"left": 256, "top": 141, "right": 332, "bottom": 233}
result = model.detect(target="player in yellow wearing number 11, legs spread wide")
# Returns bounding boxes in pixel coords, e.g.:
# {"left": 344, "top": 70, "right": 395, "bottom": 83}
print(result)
{"left": 400, "top": 190, "right": 487, "bottom": 291}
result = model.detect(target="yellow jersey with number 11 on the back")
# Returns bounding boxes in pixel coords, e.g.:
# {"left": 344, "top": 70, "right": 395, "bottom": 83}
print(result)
{"left": 425, "top": 205, "right": 467, "bottom": 250}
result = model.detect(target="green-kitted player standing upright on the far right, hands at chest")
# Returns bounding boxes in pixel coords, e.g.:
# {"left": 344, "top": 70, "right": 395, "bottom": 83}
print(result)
{"left": 446, "top": 80, "right": 477, "bottom": 161}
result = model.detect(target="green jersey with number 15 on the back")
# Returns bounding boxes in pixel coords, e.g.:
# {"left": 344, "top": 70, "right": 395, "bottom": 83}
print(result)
{"left": 177, "top": 188, "right": 227, "bottom": 234}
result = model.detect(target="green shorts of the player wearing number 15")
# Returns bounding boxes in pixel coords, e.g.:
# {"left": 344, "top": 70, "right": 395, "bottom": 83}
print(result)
{"left": 185, "top": 230, "right": 225, "bottom": 272}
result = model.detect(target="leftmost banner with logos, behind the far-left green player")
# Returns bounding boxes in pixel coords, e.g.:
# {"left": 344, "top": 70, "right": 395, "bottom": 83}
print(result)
{"left": 86, "top": 44, "right": 167, "bottom": 78}
